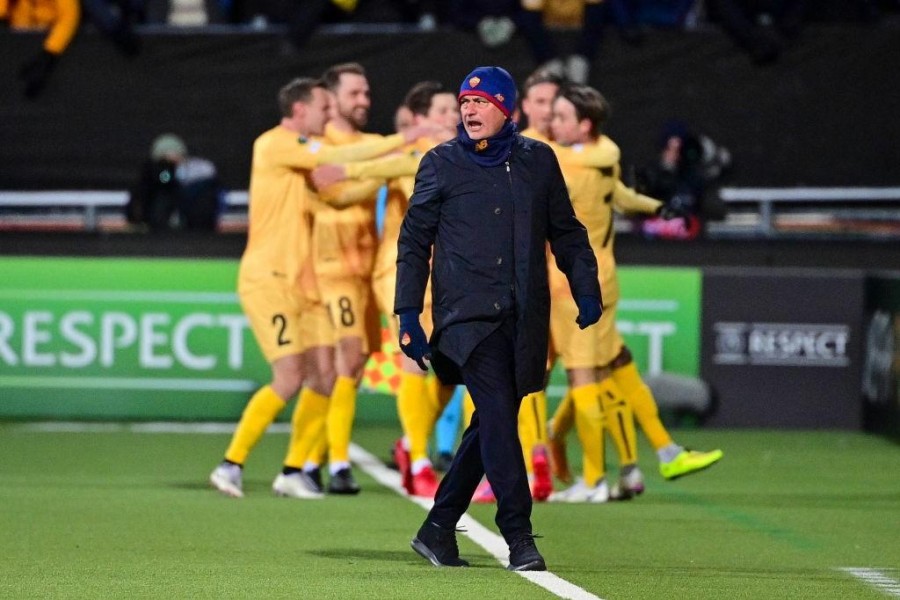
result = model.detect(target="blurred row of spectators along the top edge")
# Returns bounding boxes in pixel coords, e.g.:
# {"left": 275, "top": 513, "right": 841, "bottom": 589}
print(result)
{"left": 7, "top": 0, "right": 900, "bottom": 98}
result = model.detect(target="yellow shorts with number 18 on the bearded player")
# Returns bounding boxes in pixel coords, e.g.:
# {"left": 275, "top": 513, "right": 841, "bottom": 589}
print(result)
{"left": 319, "top": 277, "right": 381, "bottom": 352}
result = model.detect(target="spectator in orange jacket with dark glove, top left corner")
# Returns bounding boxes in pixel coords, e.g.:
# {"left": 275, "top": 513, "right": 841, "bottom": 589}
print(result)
{"left": 0, "top": 0, "right": 81, "bottom": 99}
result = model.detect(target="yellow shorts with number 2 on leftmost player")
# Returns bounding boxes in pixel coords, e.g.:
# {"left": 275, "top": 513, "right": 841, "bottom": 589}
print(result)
{"left": 238, "top": 281, "right": 309, "bottom": 363}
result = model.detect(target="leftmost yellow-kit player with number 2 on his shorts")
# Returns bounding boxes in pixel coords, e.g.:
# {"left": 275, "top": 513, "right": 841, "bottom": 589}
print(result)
{"left": 209, "top": 78, "right": 422, "bottom": 498}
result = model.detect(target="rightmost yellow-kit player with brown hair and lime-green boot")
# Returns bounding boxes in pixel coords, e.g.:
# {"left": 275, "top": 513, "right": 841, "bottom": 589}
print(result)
{"left": 551, "top": 85, "right": 722, "bottom": 502}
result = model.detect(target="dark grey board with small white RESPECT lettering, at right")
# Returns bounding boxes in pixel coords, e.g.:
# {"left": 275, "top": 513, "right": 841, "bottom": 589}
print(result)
{"left": 701, "top": 268, "right": 866, "bottom": 429}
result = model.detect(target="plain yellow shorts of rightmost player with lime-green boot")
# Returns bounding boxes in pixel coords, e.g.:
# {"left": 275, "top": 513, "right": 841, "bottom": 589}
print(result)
{"left": 550, "top": 296, "right": 625, "bottom": 369}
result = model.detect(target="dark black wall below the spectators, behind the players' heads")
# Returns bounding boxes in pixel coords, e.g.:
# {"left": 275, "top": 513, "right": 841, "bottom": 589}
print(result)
{"left": 0, "top": 23, "right": 900, "bottom": 190}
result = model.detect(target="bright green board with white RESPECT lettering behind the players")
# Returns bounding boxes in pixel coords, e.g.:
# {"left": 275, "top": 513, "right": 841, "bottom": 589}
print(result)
{"left": 0, "top": 257, "right": 701, "bottom": 421}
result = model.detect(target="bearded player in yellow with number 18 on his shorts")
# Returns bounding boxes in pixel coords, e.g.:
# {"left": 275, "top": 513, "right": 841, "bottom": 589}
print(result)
{"left": 292, "top": 63, "right": 382, "bottom": 494}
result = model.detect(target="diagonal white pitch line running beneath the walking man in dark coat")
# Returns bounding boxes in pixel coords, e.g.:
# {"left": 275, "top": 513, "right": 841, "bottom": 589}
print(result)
{"left": 350, "top": 444, "right": 603, "bottom": 600}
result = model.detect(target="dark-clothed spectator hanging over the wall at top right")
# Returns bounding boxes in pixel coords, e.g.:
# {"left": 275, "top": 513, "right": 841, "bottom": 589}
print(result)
{"left": 707, "top": 0, "right": 806, "bottom": 65}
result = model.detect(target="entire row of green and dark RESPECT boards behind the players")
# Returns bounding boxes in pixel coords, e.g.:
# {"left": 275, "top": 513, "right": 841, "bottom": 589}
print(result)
{"left": 0, "top": 256, "right": 900, "bottom": 435}
